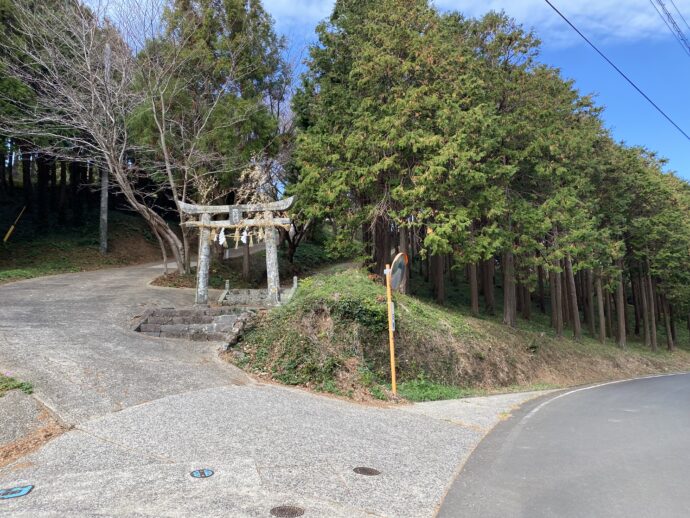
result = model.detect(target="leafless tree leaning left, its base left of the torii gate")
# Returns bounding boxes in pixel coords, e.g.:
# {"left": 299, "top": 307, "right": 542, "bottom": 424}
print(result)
{"left": 0, "top": 1, "right": 189, "bottom": 271}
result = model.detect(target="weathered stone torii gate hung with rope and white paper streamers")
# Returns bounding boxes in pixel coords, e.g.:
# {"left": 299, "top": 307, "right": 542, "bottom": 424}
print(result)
{"left": 179, "top": 196, "right": 295, "bottom": 305}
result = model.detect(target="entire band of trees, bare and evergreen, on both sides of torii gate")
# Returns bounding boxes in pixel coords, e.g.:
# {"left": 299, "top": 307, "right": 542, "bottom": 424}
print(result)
{"left": 0, "top": 0, "right": 690, "bottom": 349}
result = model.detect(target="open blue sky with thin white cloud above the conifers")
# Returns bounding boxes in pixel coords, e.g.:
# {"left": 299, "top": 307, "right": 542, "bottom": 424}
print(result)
{"left": 264, "top": 0, "right": 690, "bottom": 180}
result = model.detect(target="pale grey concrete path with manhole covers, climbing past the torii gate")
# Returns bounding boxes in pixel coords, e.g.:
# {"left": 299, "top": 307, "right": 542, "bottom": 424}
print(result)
{"left": 0, "top": 266, "right": 538, "bottom": 517}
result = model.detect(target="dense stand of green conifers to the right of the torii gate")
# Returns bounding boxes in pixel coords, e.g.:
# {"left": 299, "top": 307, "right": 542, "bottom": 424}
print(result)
{"left": 293, "top": 0, "right": 690, "bottom": 349}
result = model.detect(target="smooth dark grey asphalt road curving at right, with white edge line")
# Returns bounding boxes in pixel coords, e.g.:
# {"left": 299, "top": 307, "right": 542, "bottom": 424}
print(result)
{"left": 439, "top": 374, "right": 690, "bottom": 518}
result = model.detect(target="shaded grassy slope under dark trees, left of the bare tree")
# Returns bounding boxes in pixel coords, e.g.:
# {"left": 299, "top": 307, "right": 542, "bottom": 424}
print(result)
{"left": 0, "top": 212, "right": 160, "bottom": 284}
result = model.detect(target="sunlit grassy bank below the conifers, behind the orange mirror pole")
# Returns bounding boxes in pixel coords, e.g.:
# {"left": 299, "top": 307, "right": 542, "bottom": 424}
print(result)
{"left": 233, "top": 270, "right": 690, "bottom": 400}
